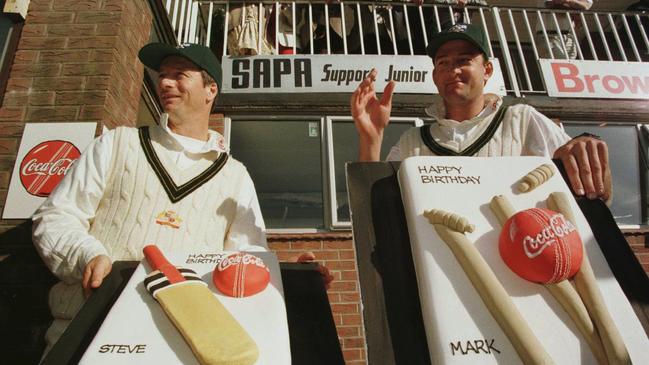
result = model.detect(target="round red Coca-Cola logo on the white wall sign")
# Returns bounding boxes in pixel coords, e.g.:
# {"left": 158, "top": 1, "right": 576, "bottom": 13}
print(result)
{"left": 20, "top": 140, "right": 81, "bottom": 197}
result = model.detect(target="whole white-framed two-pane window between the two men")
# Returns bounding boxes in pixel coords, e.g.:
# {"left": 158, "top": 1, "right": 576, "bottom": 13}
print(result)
{"left": 226, "top": 116, "right": 422, "bottom": 230}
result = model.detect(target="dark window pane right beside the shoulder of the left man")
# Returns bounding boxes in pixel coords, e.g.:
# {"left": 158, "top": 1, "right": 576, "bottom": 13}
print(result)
{"left": 230, "top": 119, "right": 324, "bottom": 228}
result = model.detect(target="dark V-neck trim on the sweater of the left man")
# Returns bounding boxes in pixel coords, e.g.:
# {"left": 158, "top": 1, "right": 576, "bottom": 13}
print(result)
{"left": 138, "top": 127, "right": 228, "bottom": 203}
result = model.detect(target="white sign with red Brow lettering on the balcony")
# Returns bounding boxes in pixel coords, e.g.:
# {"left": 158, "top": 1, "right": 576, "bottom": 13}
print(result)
{"left": 539, "top": 59, "right": 649, "bottom": 99}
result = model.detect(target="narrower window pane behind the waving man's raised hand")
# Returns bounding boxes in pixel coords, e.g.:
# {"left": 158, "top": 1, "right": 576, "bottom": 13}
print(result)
{"left": 332, "top": 120, "right": 414, "bottom": 222}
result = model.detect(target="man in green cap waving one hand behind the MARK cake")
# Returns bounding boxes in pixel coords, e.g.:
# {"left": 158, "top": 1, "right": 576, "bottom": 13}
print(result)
{"left": 350, "top": 23, "right": 611, "bottom": 200}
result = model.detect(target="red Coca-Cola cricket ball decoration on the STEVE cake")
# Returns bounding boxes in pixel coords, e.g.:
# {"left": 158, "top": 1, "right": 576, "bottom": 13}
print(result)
{"left": 212, "top": 252, "right": 270, "bottom": 298}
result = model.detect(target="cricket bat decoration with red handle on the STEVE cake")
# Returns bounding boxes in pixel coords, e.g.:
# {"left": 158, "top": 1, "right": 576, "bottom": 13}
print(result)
{"left": 143, "top": 245, "right": 259, "bottom": 365}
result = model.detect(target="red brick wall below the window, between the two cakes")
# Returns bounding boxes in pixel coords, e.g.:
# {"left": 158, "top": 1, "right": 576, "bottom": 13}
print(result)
{"left": 268, "top": 232, "right": 367, "bottom": 364}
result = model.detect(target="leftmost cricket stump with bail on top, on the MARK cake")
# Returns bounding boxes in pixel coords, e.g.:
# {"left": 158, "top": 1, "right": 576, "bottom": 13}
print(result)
{"left": 424, "top": 209, "right": 554, "bottom": 364}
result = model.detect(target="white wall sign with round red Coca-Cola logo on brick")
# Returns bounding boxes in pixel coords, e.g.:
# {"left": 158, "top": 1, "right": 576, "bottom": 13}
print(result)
{"left": 2, "top": 123, "right": 97, "bottom": 219}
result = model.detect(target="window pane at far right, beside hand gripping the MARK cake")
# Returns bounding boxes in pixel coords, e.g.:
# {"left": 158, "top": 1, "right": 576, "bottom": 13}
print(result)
{"left": 564, "top": 124, "right": 646, "bottom": 225}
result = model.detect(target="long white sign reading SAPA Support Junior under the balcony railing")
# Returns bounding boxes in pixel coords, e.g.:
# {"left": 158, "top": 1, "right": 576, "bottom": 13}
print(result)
{"left": 222, "top": 55, "right": 507, "bottom": 95}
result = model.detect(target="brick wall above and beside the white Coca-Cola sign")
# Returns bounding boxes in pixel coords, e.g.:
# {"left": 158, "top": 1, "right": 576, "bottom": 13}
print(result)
{"left": 0, "top": 0, "right": 152, "bottom": 225}
